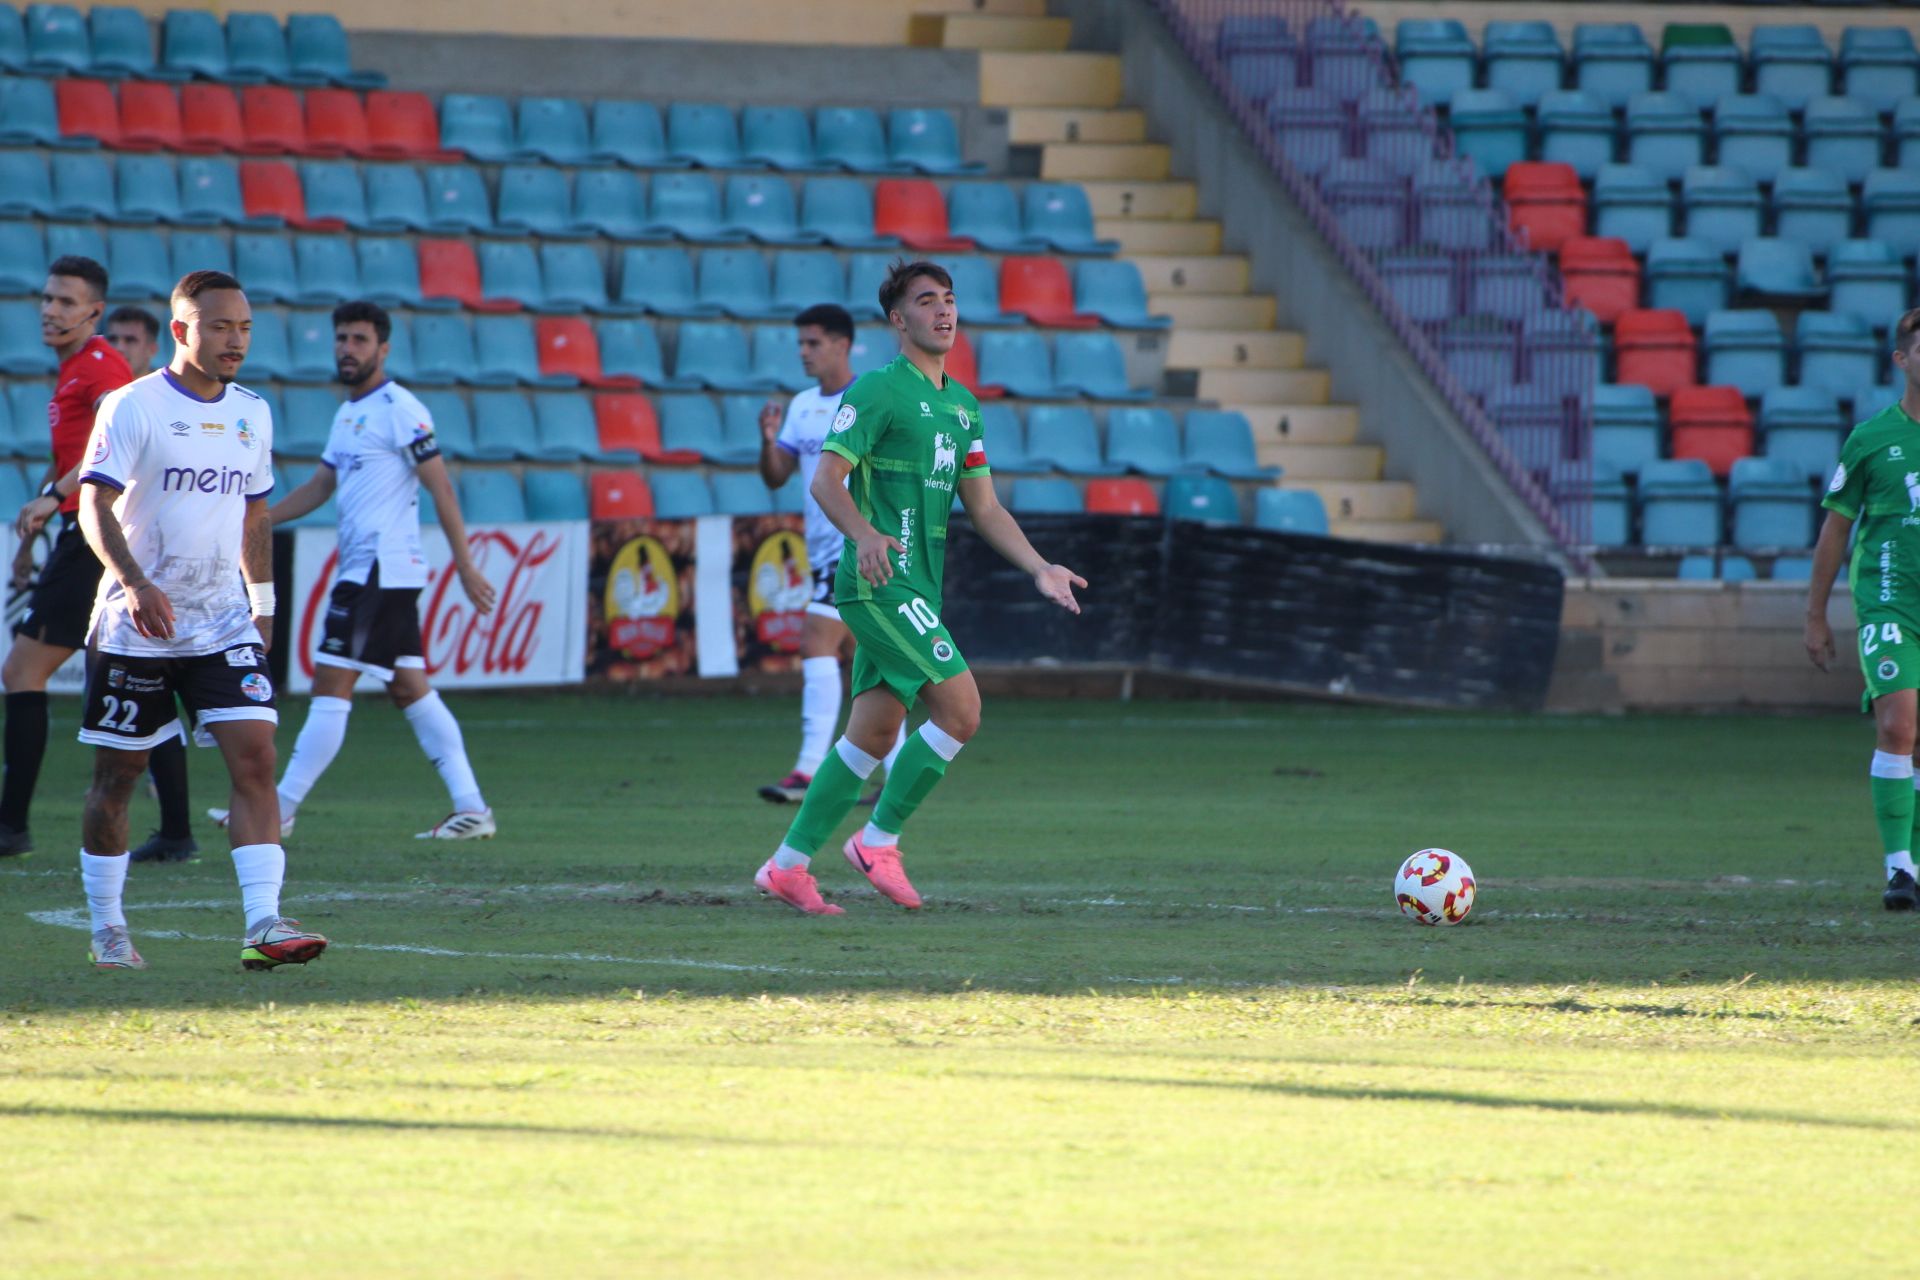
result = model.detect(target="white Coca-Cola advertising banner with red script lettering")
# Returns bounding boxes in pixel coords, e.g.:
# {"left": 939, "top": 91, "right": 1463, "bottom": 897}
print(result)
{"left": 280, "top": 520, "right": 588, "bottom": 693}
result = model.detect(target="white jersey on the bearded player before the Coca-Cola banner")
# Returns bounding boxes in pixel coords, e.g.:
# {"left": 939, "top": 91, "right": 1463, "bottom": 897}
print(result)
{"left": 321, "top": 382, "right": 440, "bottom": 589}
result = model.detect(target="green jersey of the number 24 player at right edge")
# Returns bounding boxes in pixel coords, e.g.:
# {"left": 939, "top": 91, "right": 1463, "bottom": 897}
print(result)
{"left": 1822, "top": 403, "right": 1920, "bottom": 629}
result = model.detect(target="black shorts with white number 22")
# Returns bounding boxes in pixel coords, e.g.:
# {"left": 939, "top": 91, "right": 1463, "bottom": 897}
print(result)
{"left": 81, "top": 643, "right": 280, "bottom": 750}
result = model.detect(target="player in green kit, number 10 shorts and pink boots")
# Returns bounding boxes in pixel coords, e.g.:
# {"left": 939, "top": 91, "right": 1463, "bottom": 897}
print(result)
{"left": 755, "top": 263, "right": 1087, "bottom": 915}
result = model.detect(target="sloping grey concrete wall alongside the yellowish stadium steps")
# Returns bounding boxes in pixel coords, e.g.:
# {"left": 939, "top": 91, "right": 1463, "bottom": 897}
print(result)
{"left": 1050, "top": 0, "right": 1551, "bottom": 547}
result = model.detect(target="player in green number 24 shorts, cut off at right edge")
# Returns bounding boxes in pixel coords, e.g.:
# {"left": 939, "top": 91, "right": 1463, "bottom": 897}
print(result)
{"left": 1807, "top": 309, "right": 1920, "bottom": 912}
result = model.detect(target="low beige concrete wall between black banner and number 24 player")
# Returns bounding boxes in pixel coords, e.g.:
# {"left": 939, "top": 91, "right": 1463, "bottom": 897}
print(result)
{"left": 1548, "top": 580, "right": 1862, "bottom": 712}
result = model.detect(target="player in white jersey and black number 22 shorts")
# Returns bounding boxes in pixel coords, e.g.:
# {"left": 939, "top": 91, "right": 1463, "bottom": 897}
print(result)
{"left": 81, "top": 271, "right": 326, "bottom": 969}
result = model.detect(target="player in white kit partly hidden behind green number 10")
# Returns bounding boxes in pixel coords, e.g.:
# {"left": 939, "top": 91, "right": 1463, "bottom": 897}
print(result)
{"left": 760, "top": 303, "right": 906, "bottom": 804}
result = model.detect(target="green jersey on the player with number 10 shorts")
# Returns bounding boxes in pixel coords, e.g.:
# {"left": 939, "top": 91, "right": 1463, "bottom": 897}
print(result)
{"left": 822, "top": 355, "right": 989, "bottom": 612}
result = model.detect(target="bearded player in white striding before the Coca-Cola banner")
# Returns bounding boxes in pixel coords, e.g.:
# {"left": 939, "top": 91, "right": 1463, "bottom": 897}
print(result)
{"left": 232, "top": 301, "right": 497, "bottom": 841}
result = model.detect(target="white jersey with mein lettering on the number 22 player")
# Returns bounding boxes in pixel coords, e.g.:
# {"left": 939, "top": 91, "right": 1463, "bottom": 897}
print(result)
{"left": 81, "top": 368, "right": 273, "bottom": 658}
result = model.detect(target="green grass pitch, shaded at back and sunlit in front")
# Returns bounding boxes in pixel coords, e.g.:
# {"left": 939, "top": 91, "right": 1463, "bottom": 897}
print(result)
{"left": 0, "top": 697, "right": 1920, "bottom": 1280}
